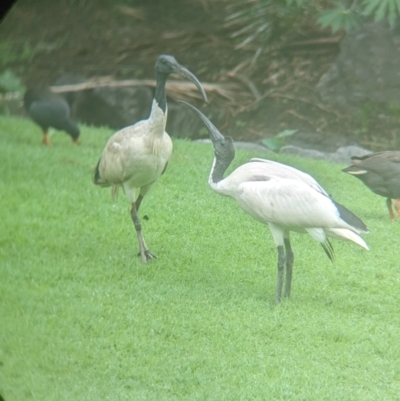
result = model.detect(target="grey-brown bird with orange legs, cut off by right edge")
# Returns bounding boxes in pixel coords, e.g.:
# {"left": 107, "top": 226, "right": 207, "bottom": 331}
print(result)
{"left": 342, "top": 151, "right": 400, "bottom": 220}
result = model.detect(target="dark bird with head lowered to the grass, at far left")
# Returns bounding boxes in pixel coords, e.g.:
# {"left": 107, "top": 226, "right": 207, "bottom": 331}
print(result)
{"left": 24, "top": 89, "right": 80, "bottom": 146}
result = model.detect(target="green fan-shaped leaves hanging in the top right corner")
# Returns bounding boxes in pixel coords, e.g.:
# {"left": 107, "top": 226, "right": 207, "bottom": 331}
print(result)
{"left": 225, "top": 0, "right": 400, "bottom": 49}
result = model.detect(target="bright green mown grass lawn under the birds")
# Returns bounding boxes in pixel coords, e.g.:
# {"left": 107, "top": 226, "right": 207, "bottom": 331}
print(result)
{"left": 0, "top": 114, "right": 400, "bottom": 401}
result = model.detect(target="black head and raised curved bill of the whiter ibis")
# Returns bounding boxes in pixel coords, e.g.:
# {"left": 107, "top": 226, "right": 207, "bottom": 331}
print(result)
{"left": 179, "top": 100, "right": 235, "bottom": 168}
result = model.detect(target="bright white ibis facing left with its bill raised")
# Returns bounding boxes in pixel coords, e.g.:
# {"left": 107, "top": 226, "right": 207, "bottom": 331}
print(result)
{"left": 180, "top": 101, "right": 368, "bottom": 303}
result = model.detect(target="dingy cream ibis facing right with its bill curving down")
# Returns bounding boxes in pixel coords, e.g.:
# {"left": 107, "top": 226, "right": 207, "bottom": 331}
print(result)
{"left": 93, "top": 55, "right": 207, "bottom": 263}
